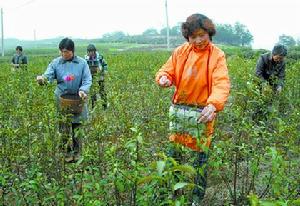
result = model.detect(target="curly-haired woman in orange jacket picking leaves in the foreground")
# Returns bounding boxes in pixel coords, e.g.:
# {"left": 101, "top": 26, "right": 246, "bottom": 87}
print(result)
{"left": 155, "top": 13, "right": 230, "bottom": 204}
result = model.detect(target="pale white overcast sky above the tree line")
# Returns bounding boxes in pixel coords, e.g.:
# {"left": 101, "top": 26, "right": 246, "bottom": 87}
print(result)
{"left": 0, "top": 0, "right": 300, "bottom": 49}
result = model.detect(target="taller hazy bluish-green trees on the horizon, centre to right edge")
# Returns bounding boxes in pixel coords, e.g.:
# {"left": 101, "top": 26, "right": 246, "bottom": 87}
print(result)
{"left": 101, "top": 22, "right": 300, "bottom": 48}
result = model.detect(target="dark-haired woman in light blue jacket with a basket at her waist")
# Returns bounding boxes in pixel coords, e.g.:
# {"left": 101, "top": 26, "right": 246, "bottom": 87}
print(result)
{"left": 36, "top": 38, "right": 92, "bottom": 162}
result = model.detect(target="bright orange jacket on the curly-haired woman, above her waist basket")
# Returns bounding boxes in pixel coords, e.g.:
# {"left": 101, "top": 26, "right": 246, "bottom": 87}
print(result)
{"left": 156, "top": 42, "right": 230, "bottom": 111}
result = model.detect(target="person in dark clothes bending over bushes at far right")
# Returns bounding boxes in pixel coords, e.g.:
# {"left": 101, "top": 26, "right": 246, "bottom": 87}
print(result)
{"left": 255, "top": 44, "right": 287, "bottom": 93}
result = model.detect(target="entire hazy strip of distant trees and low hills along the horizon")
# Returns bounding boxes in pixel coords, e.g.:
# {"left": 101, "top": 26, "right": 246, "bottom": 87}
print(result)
{"left": 4, "top": 22, "right": 300, "bottom": 52}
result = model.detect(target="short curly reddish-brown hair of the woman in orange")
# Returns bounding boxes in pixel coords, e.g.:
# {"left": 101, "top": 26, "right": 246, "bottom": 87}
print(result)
{"left": 181, "top": 14, "right": 216, "bottom": 40}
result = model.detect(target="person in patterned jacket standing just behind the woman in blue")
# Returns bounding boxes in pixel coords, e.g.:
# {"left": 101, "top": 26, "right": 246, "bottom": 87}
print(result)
{"left": 84, "top": 44, "right": 108, "bottom": 110}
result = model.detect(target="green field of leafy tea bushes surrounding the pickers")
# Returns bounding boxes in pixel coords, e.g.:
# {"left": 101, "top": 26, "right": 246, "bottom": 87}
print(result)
{"left": 0, "top": 45, "right": 300, "bottom": 206}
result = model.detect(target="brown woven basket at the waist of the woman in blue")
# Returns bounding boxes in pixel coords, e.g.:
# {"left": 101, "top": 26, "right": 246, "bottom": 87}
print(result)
{"left": 59, "top": 94, "right": 84, "bottom": 114}
